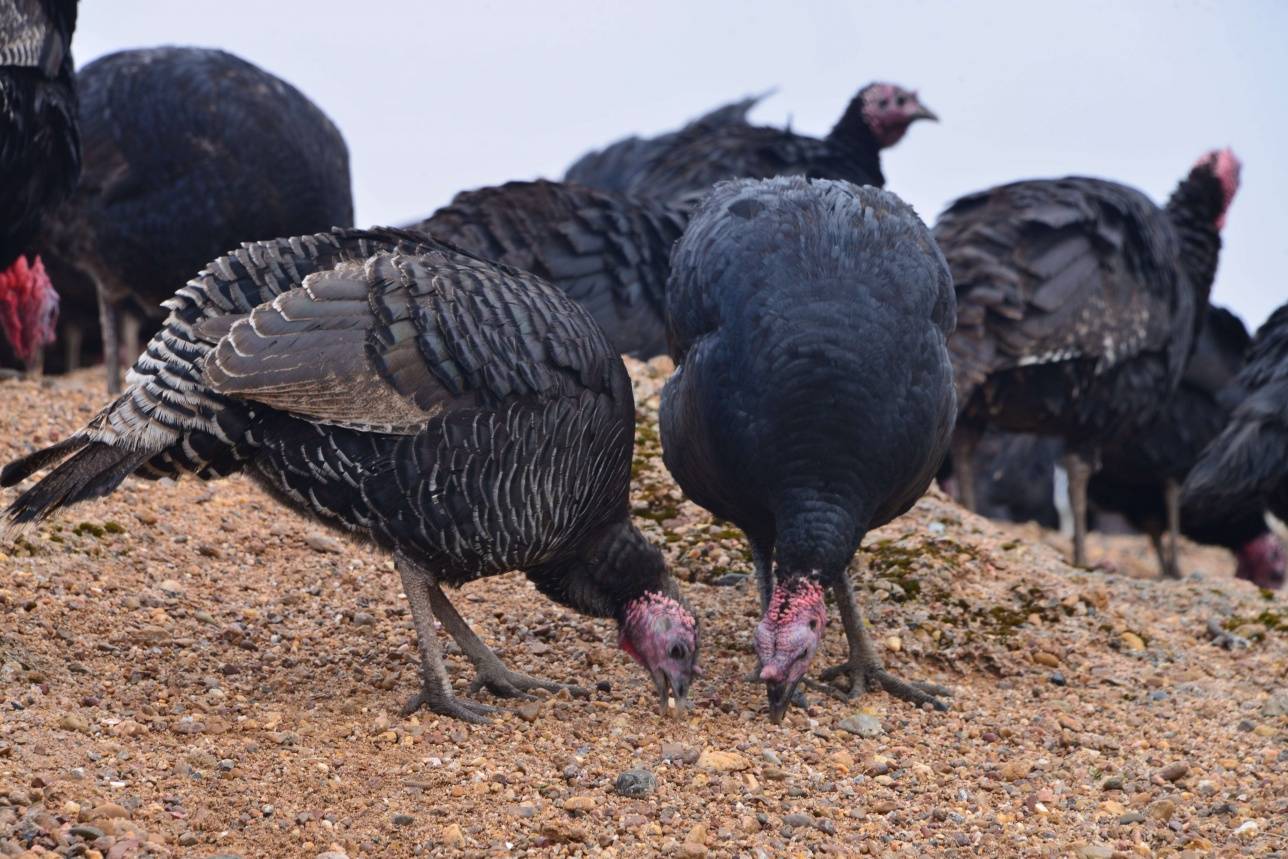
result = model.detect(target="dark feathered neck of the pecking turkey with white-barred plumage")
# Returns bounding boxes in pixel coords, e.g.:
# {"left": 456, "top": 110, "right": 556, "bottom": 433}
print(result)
{"left": 526, "top": 510, "right": 677, "bottom": 621}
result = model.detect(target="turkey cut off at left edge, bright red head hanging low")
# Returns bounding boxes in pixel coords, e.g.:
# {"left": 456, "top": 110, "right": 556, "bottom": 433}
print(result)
{"left": 0, "top": 0, "right": 81, "bottom": 373}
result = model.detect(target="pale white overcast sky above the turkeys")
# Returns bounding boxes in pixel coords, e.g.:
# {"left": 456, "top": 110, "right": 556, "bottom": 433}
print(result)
{"left": 73, "top": 0, "right": 1288, "bottom": 326}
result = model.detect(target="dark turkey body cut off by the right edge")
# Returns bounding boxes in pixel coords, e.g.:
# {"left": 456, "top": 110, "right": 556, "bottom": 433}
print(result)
{"left": 1182, "top": 298, "right": 1288, "bottom": 585}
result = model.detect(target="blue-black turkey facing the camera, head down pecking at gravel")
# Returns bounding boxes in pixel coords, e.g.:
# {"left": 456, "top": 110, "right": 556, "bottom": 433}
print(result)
{"left": 659, "top": 176, "right": 956, "bottom": 721}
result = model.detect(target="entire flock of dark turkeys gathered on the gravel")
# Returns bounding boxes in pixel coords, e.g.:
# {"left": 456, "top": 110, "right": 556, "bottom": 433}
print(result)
{"left": 0, "top": 0, "right": 1288, "bottom": 722}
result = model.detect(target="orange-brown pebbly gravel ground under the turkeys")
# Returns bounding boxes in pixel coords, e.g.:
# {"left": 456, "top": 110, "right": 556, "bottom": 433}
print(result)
{"left": 0, "top": 362, "right": 1288, "bottom": 859}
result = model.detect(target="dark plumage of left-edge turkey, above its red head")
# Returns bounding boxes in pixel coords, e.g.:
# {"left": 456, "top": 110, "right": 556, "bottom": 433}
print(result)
{"left": 0, "top": 0, "right": 81, "bottom": 272}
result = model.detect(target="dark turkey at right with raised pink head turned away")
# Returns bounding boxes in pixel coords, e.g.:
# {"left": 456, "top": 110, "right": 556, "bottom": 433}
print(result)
{"left": 935, "top": 149, "right": 1239, "bottom": 567}
